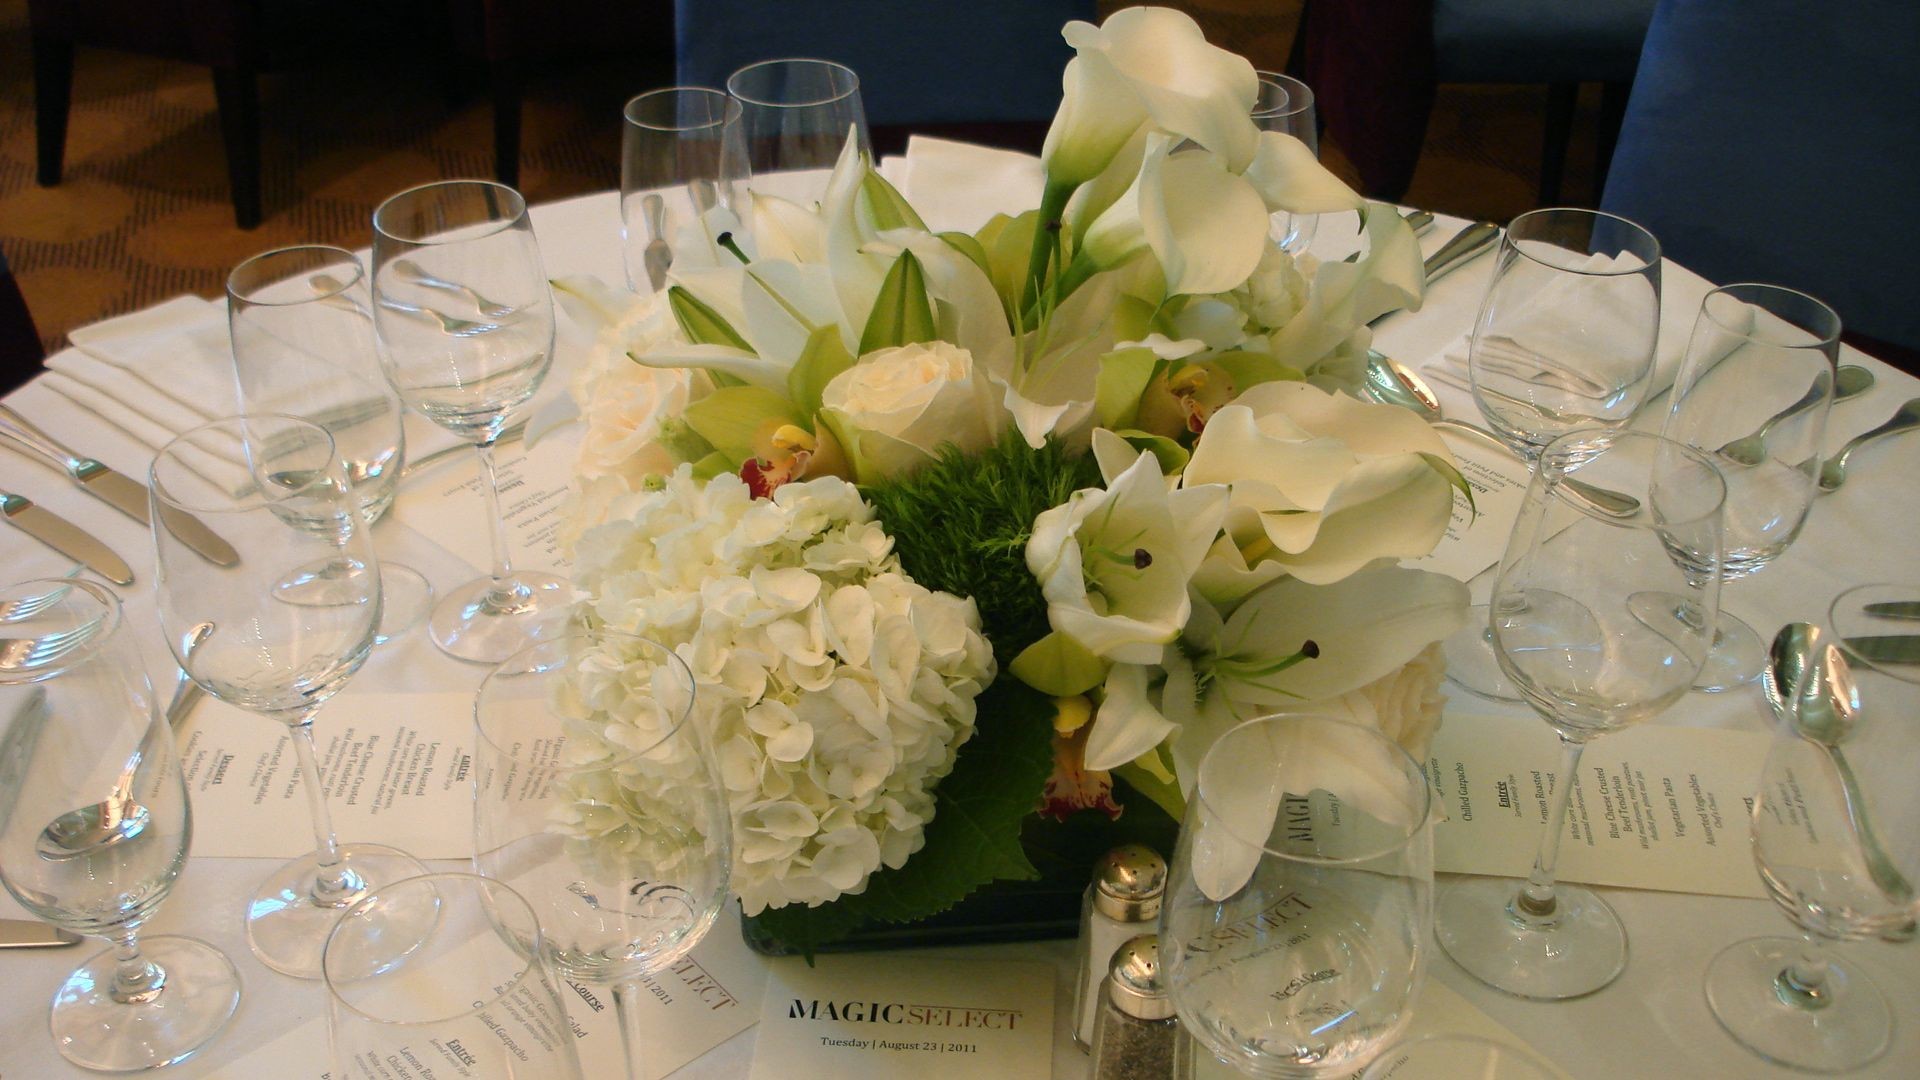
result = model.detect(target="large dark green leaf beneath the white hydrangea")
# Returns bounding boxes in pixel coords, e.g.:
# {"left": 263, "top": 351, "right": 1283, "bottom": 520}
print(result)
{"left": 755, "top": 676, "right": 1054, "bottom": 957}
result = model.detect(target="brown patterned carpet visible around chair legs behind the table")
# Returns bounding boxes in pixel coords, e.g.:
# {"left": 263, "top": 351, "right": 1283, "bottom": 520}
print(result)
{"left": 0, "top": 0, "right": 1592, "bottom": 350}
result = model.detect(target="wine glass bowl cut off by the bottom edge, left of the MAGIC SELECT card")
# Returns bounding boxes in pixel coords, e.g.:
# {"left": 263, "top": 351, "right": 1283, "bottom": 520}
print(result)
{"left": 324, "top": 874, "right": 580, "bottom": 1080}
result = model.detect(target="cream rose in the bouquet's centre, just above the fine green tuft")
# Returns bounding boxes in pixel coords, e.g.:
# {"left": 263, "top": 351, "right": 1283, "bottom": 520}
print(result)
{"left": 820, "top": 342, "right": 998, "bottom": 482}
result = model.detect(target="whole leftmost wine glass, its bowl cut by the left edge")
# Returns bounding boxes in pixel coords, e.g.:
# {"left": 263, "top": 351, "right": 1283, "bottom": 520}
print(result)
{"left": 0, "top": 578, "right": 240, "bottom": 1072}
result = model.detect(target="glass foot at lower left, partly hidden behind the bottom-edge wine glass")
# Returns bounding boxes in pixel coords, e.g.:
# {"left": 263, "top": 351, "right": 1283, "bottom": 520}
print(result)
{"left": 246, "top": 844, "right": 426, "bottom": 978}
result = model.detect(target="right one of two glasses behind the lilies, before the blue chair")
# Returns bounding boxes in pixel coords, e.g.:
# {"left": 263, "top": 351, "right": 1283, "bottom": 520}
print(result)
{"left": 726, "top": 60, "right": 874, "bottom": 204}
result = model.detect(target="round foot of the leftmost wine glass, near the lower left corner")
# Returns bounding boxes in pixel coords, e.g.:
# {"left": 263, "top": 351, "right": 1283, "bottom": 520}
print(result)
{"left": 48, "top": 936, "right": 240, "bottom": 1072}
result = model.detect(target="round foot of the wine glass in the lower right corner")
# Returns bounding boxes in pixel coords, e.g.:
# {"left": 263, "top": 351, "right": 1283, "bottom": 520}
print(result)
{"left": 1707, "top": 938, "right": 1893, "bottom": 1072}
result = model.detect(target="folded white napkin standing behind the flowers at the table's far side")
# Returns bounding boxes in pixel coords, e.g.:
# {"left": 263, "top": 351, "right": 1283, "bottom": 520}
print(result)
{"left": 885, "top": 135, "right": 1046, "bottom": 233}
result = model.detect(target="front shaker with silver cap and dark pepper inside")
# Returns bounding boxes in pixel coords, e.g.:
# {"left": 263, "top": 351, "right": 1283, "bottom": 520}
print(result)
{"left": 1092, "top": 934, "right": 1192, "bottom": 1080}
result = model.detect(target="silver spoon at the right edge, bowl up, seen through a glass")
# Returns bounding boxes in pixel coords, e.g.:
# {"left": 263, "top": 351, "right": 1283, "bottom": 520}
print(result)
{"left": 1761, "top": 623, "right": 1914, "bottom": 903}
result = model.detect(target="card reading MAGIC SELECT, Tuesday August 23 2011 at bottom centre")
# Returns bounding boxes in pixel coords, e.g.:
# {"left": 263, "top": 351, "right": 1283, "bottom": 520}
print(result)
{"left": 749, "top": 953, "right": 1054, "bottom": 1080}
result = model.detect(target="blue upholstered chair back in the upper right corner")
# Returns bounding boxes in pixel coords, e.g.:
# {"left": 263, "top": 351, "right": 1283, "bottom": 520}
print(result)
{"left": 1603, "top": 0, "right": 1920, "bottom": 350}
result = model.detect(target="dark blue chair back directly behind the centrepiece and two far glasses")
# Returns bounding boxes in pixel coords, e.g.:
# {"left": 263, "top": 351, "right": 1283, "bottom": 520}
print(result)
{"left": 674, "top": 0, "right": 1098, "bottom": 135}
